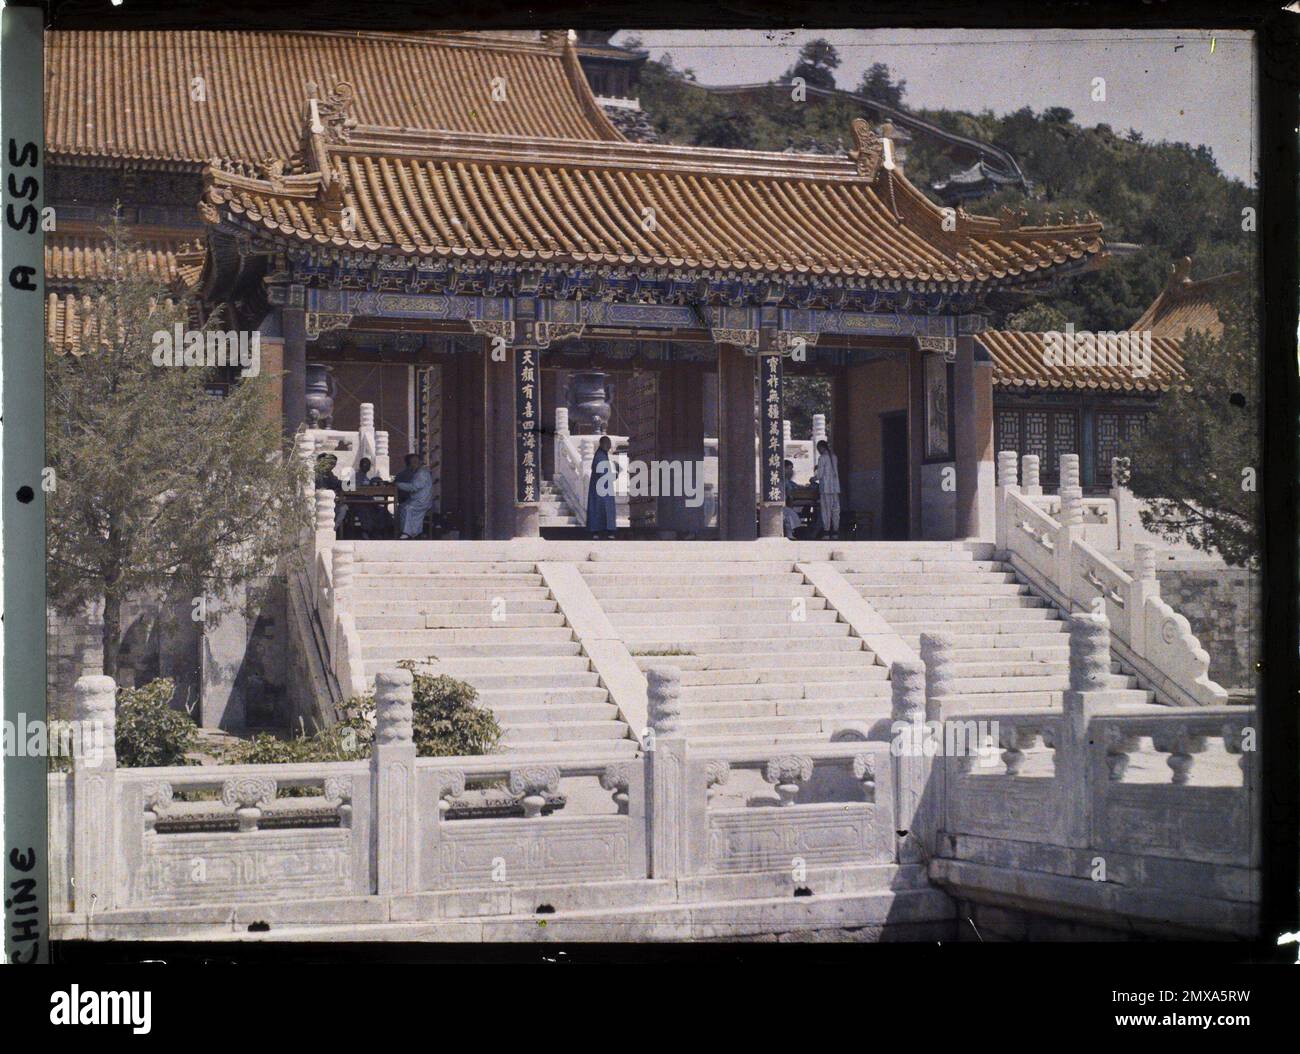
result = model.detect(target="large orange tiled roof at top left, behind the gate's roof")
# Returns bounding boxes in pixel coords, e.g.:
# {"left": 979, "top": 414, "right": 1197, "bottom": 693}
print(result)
{"left": 46, "top": 31, "right": 621, "bottom": 164}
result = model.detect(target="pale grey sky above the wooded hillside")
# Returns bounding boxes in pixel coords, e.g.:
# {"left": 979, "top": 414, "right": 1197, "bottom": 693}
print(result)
{"left": 614, "top": 29, "right": 1257, "bottom": 185}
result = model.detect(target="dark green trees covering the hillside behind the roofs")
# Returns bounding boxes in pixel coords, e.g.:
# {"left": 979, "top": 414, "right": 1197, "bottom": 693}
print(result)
{"left": 640, "top": 62, "right": 1257, "bottom": 331}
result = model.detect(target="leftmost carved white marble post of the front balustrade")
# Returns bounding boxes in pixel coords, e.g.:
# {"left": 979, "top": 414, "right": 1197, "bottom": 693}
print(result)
{"left": 72, "top": 675, "right": 117, "bottom": 914}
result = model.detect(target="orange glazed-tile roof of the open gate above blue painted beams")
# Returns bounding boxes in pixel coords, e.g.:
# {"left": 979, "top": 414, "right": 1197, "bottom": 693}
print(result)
{"left": 203, "top": 121, "right": 1104, "bottom": 287}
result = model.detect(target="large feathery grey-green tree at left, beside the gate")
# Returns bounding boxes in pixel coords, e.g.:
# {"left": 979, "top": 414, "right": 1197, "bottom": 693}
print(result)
{"left": 46, "top": 224, "right": 309, "bottom": 677}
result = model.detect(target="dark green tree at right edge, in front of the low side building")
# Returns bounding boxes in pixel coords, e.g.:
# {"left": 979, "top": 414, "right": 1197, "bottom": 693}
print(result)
{"left": 1123, "top": 292, "right": 1260, "bottom": 567}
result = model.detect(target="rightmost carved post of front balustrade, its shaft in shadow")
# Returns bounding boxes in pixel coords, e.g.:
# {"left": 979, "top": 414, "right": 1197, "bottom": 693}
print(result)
{"left": 1052, "top": 612, "right": 1110, "bottom": 846}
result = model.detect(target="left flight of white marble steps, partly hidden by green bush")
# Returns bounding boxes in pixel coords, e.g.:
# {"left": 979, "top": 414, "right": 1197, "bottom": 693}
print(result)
{"left": 352, "top": 552, "right": 637, "bottom": 756}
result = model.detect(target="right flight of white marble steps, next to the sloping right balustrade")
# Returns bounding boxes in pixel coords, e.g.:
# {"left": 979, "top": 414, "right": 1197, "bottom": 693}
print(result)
{"left": 833, "top": 542, "right": 1154, "bottom": 708}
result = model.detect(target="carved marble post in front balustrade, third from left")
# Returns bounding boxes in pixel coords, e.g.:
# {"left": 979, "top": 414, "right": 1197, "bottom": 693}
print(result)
{"left": 642, "top": 665, "right": 686, "bottom": 879}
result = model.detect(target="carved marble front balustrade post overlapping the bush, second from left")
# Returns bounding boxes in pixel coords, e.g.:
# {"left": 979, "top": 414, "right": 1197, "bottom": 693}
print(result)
{"left": 371, "top": 669, "right": 416, "bottom": 894}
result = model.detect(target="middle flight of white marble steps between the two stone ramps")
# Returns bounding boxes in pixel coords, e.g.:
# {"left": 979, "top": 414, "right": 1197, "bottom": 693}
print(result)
{"left": 580, "top": 556, "right": 889, "bottom": 746}
